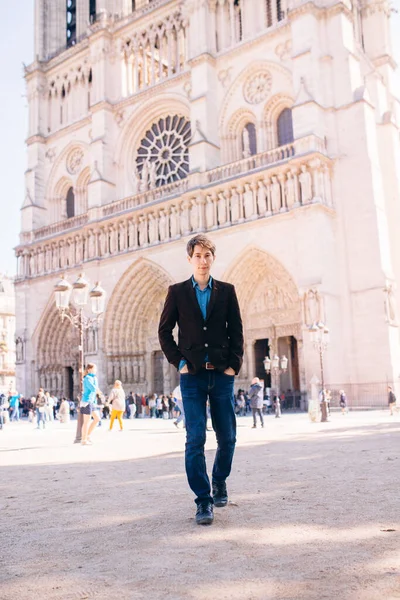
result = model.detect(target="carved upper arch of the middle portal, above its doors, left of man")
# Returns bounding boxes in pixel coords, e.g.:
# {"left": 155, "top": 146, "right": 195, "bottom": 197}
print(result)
{"left": 103, "top": 258, "right": 174, "bottom": 356}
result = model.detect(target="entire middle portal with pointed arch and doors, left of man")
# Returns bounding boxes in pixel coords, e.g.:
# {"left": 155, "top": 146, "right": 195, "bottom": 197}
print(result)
{"left": 103, "top": 258, "right": 176, "bottom": 393}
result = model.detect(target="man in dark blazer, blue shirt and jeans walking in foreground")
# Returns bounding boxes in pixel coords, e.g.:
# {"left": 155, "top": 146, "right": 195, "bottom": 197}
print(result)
{"left": 158, "top": 235, "right": 243, "bottom": 525}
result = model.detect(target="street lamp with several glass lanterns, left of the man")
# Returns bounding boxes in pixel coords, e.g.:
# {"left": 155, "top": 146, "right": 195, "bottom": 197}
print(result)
{"left": 54, "top": 274, "right": 106, "bottom": 443}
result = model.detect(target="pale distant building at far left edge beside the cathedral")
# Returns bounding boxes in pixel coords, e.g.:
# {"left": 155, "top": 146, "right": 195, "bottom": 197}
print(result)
{"left": 0, "top": 274, "right": 16, "bottom": 395}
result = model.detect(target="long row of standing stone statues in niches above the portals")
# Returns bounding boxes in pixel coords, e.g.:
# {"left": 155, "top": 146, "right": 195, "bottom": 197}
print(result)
{"left": 17, "top": 154, "right": 333, "bottom": 279}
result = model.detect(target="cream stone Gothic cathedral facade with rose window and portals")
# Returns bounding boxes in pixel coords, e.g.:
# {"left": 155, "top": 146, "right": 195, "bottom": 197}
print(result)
{"left": 16, "top": 0, "right": 400, "bottom": 404}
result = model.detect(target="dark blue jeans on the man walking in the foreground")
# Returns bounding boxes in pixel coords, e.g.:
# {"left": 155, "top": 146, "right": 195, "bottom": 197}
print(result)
{"left": 180, "top": 369, "right": 236, "bottom": 504}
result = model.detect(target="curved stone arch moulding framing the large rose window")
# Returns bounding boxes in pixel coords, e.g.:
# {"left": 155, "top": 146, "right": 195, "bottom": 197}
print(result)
{"left": 115, "top": 94, "right": 190, "bottom": 198}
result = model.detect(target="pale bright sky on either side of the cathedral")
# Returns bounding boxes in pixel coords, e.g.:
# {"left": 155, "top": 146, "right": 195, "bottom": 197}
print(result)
{"left": 0, "top": 0, "right": 400, "bottom": 275}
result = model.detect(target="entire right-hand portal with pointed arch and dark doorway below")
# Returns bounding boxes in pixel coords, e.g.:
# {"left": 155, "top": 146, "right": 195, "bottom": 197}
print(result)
{"left": 224, "top": 247, "right": 306, "bottom": 391}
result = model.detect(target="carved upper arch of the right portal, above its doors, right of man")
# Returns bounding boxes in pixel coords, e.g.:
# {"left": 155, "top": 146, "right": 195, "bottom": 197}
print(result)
{"left": 224, "top": 247, "right": 301, "bottom": 329}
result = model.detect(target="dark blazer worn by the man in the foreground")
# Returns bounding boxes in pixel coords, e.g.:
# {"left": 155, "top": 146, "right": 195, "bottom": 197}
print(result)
{"left": 158, "top": 278, "right": 243, "bottom": 374}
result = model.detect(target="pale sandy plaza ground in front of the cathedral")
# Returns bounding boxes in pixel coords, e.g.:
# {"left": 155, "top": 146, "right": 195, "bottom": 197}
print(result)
{"left": 0, "top": 411, "right": 400, "bottom": 600}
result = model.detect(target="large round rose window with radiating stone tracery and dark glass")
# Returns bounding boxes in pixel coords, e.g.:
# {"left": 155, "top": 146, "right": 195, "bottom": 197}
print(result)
{"left": 136, "top": 115, "right": 190, "bottom": 187}
